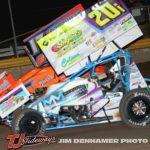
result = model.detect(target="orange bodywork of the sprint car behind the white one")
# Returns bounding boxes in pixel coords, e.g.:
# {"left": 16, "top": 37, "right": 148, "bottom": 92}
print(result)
{"left": 0, "top": 66, "right": 65, "bottom": 98}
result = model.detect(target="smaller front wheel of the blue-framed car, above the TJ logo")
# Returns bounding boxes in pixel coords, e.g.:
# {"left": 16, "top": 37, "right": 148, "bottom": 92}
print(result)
{"left": 12, "top": 109, "right": 46, "bottom": 136}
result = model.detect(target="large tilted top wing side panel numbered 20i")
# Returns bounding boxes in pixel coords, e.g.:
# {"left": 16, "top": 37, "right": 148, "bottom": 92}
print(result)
{"left": 37, "top": 0, "right": 142, "bottom": 74}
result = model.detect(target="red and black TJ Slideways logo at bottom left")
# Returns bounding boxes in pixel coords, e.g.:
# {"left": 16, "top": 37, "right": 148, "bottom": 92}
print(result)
{"left": 7, "top": 134, "right": 56, "bottom": 149}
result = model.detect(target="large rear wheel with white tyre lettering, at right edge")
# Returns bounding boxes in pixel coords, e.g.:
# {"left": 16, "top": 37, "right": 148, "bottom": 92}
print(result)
{"left": 119, "top": 89, "right": 150, "bottom": 128}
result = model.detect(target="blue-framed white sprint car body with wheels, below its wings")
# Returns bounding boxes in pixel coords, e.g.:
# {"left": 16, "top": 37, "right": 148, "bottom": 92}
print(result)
{"left": 2, "top": 50, "right": 150, "bottom": 135}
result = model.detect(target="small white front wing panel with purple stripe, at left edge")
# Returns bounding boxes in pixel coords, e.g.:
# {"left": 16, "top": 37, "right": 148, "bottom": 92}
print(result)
{"left": 0, "top": 84, "right": 30, "bottom": 118}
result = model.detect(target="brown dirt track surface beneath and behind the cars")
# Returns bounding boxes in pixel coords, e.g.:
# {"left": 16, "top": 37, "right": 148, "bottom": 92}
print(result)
{"left": 0, "top": 62, "right": 150, "bottom": 150}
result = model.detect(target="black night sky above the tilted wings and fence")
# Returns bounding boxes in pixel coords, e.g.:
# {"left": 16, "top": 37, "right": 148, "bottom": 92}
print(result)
{"left": 0, "top": 0, "right": 150, "bottom": 42}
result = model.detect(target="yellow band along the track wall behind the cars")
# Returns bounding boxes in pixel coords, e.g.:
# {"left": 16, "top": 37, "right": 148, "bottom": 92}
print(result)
{"left": 0, "top": 38, "right": 150, "bottom": 69}
